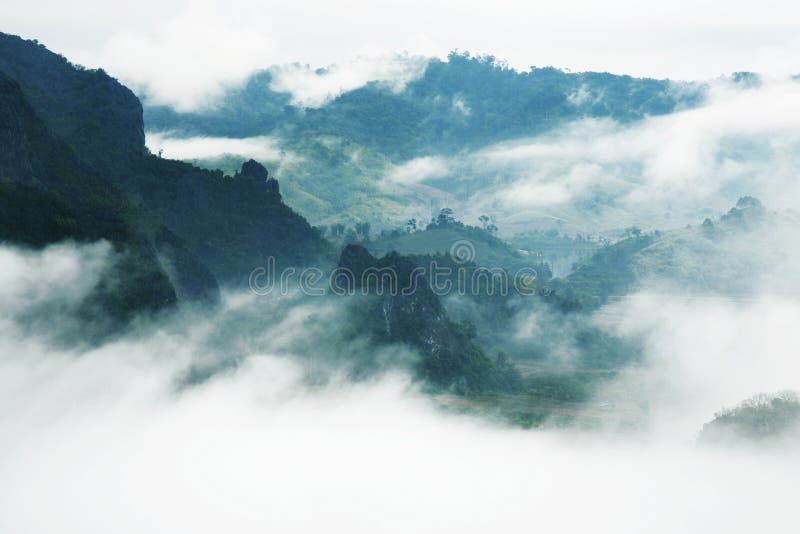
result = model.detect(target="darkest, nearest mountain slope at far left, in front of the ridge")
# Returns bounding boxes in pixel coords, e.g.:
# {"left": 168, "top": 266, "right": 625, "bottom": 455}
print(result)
{"left": 0, "top": 73, "right": 183, "bottom": 320}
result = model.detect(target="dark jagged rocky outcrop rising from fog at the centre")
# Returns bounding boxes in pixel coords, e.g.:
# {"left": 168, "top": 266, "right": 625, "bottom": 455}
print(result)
{"left": 337, "top": 245, "right": 520, "bottom": 393}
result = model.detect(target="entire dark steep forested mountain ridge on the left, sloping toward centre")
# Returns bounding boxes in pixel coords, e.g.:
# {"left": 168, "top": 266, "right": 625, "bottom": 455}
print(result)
{"left": 0, "top": 34, "right": 334, "bottom": 312}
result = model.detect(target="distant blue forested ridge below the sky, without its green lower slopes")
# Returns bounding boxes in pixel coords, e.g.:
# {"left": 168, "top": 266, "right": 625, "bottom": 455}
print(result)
{"left": 145, "top": 52, "right": 705, "bottom": 162}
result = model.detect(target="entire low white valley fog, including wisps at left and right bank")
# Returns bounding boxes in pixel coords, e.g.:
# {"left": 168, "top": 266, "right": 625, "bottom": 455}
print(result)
{"left": 0, "top": 244, "right": 800, "bottom": 534}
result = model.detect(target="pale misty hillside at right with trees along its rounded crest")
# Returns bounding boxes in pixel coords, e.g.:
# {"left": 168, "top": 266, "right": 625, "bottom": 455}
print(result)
{"left": 550, "top": 197, "right": 800, "bottom": 309}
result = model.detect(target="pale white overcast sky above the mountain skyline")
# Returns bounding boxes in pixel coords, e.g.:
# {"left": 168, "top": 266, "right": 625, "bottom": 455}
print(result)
{"left": 0, "top": 0, "right": 800, "bottom": 107}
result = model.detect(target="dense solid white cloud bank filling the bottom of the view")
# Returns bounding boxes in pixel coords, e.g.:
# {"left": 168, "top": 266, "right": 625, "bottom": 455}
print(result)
{"left": 0, "top": 298, "right": 795, "bottom": 533}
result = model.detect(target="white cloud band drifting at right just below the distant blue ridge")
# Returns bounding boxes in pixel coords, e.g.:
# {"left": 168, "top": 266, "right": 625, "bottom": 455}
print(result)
{"left": 393, "top": 80, "right": 800, "bottom": 232}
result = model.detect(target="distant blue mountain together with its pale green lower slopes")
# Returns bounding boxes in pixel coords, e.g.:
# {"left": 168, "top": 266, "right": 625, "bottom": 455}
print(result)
{"left": 144, "top": 53, "right": 706, "bottom": 228}
